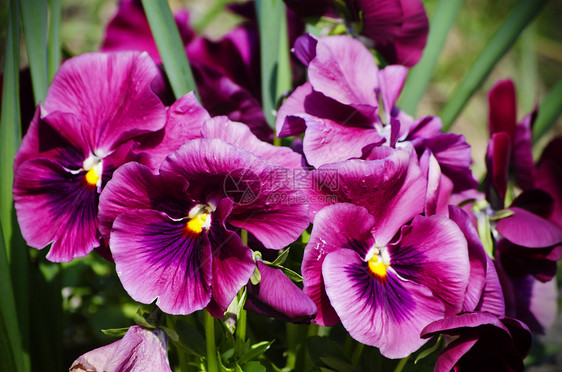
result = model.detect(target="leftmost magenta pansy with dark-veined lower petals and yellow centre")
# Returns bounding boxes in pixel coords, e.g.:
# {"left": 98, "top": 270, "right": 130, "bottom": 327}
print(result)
{"left": 14, "top": 52, "right": 166, "bottom": 261}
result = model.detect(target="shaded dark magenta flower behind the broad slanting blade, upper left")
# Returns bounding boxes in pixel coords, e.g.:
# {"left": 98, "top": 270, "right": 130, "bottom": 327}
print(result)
{"left": 102, "top": 0, "right": 273, "bottom": 141}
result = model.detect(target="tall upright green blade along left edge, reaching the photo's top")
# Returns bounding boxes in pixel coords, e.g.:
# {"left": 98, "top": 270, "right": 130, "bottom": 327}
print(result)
{"left": 0, "top": 0, "right": 21, "bottom": 261}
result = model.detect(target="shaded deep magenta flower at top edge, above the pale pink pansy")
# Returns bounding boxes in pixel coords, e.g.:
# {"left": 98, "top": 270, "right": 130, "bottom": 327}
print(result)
{"left": 285, "top": 0, "right": 429, "bottom": 67}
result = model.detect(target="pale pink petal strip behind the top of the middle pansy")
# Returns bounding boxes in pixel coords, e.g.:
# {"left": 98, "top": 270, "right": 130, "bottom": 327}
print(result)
{"left": 202, "top": 116, "right": 303, "bottom": 171}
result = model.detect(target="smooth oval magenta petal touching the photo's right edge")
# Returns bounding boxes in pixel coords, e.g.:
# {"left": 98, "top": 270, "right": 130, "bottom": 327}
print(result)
{"left": 496, "top": 207, "right": 562, "bottom": 248}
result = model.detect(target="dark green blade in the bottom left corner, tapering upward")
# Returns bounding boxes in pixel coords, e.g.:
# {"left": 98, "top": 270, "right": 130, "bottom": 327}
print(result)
{"left": 0, "top": 227, "right": 24, "bottom": 372}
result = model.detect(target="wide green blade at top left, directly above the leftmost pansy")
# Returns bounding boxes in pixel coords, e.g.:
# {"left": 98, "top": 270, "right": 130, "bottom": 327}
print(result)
{"left": 20, "top": 0, "right": 49, "bottom": 104}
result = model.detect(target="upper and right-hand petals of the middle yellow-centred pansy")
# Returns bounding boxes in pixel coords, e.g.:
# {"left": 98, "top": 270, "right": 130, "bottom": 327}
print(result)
{"left": 161, "top": 138, "right": 308, "bottom": 249}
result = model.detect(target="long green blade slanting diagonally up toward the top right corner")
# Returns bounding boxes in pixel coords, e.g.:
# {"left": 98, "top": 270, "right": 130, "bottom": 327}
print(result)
{"left": 439, "top": 0, "right": 547, "bottom": 131}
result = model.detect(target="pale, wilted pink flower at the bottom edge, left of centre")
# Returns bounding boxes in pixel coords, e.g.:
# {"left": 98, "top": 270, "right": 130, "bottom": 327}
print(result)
{"left": 70, "top": 326, "right": 168, "bottom": 372}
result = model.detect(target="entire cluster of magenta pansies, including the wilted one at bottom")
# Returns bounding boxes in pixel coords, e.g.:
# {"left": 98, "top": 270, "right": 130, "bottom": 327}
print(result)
{"left": 10, "top": 0, "right": 562, "bottom": 371}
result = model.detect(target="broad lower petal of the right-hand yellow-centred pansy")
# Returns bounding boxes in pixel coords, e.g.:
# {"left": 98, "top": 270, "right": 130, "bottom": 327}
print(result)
{"left": 322, "top": 249, "right": 444, "bottom": 358}
